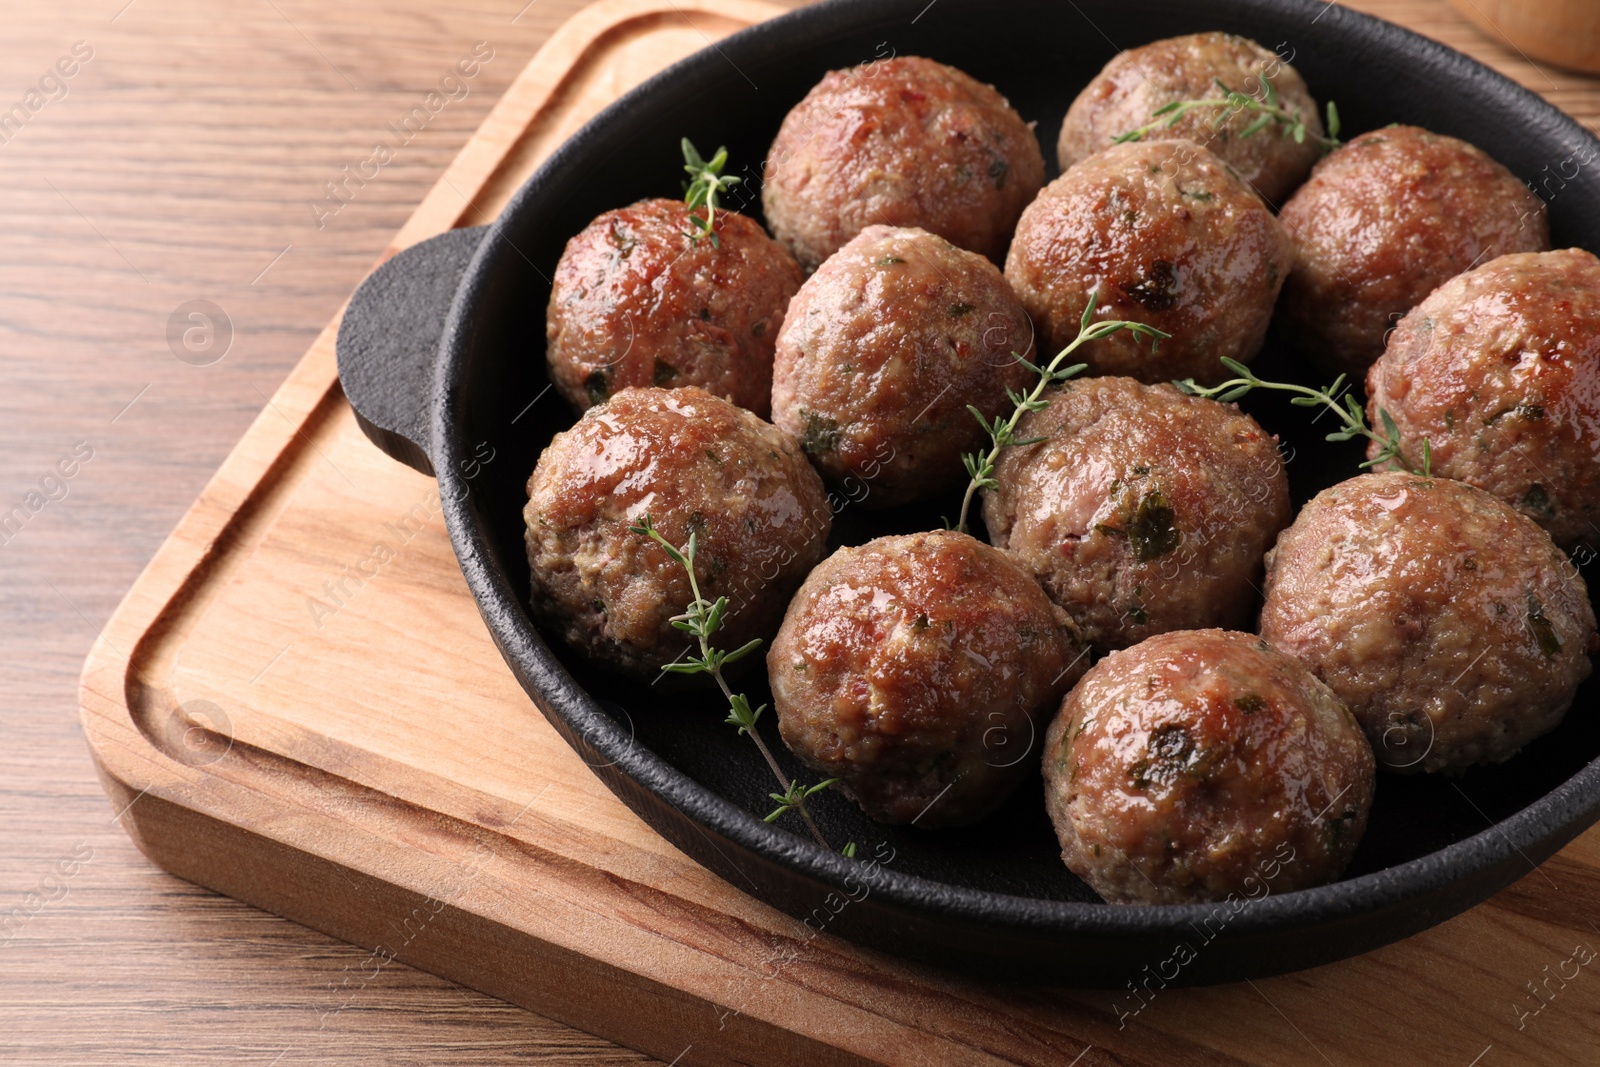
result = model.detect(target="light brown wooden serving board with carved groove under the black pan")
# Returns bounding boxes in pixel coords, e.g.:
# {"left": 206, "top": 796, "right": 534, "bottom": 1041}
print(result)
{"left": 82, "top": 0, "right": 1600, "bottom": 1067}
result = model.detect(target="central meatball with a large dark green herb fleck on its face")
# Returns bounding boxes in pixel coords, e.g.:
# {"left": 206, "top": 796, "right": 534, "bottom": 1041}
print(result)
{"left": 984, "top": 378, "right": 1290, "bottom": 649}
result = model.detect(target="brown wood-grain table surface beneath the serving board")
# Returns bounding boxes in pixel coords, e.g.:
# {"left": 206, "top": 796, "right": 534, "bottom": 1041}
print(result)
{"left": 0, "top": 0, "right": 1600, "bottom": 1067}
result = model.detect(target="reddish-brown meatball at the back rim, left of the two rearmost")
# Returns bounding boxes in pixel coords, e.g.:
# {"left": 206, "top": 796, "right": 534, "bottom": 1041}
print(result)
{"left": 762, "top": 56, "right": 1045, "bottom": 270}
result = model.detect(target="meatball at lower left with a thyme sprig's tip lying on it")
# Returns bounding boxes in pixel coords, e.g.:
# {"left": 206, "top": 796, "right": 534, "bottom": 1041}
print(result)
{"left": 523, "top": 386, "right": 832, "bottom": 681}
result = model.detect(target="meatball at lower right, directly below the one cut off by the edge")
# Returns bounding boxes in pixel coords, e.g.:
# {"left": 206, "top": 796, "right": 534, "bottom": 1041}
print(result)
{"left": 1261, "top": 472, "right": 1597, "bottom": 771}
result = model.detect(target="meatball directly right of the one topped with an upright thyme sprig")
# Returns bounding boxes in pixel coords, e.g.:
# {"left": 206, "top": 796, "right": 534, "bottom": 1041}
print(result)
{"left": 773, "top": 226, "right": 1034, "bottom": 507}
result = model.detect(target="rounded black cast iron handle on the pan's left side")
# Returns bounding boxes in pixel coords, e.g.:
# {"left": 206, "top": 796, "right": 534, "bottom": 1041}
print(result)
{"left": 338, "top": 226, "right": 490, "bottom": 475}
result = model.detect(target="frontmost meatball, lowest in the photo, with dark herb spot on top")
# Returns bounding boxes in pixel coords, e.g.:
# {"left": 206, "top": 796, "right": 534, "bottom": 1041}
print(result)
{"left": 1045, "top": 630, "right": 1374, "bottom": 904}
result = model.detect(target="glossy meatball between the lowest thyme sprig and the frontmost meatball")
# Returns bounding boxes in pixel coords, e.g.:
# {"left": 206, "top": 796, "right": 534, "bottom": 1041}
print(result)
{"left": 766, "top": 531, "right": 1086, "bottom": 827}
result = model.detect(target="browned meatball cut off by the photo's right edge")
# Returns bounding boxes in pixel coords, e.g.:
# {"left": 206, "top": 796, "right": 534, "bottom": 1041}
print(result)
{"left": 1366, "top": 248, "right": 1600, "bottom": 547}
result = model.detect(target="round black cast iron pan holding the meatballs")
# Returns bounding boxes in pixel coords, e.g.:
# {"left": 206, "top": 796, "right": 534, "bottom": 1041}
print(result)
{"left": 339, "top": 0, "right": 1600, "bottom": 987}
